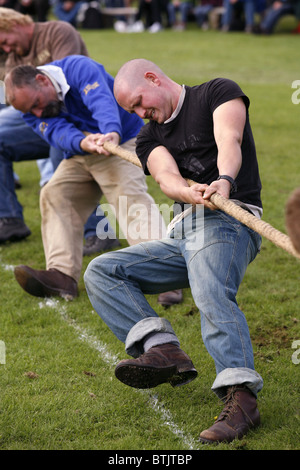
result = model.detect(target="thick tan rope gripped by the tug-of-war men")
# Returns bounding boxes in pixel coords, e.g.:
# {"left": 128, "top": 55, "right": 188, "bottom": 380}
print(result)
{"left": 103, "top": 142, "right": 300, "bottom": 259}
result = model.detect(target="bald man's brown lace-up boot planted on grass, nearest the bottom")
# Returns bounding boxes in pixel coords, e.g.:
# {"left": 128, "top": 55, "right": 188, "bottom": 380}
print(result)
{"left": 199, "top": 385, "right": 260, "bottom": 443}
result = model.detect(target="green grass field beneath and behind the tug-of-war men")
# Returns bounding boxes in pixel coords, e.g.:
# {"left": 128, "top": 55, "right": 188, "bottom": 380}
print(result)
{"left": 0, "top": 18, "right": 300, "bottom": 454}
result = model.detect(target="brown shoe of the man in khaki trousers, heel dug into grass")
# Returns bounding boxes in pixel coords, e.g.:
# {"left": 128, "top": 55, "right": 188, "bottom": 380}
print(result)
{"left": 15, "top": 266, "right": 78, "bottom": 300}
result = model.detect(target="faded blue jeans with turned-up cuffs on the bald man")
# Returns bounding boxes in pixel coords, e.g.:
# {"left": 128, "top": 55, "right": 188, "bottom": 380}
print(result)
{"left": 84, "top": 206, "right": 263, "bottom": 396}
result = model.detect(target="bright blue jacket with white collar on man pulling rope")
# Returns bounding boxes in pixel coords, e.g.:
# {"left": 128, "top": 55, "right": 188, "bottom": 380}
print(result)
{"left": 23, "top": 55, "right": 144, "bottom": 158}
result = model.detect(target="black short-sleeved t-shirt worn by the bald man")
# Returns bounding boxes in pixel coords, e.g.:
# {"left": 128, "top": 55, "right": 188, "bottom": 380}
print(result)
{"left": 136, "top": 78, "right": 262, "bottom": 207}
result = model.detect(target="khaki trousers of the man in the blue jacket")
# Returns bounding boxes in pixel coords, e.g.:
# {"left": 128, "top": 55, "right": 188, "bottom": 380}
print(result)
{"left": 40, "top": 139, "right": 166, "bottom": 282}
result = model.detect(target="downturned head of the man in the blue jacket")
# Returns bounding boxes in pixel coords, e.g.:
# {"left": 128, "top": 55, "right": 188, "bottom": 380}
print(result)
{"left": 10, "top": 76, "right": 62, "bottom": 118}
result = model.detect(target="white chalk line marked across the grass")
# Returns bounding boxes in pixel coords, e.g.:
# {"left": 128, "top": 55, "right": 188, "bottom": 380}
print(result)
{"left": 0, "top": 259, "right": 197, "bottom": 450}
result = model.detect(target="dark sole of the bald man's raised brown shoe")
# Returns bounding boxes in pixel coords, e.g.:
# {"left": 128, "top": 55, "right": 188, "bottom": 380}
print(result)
{"left": 115, "top": 364, "right": 198, "bottom": 389}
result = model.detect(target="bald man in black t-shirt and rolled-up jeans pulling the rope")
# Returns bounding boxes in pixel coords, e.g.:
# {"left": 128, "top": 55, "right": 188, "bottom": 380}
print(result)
{"left": 85, "top": 59, "right": 263, "bottom": 442}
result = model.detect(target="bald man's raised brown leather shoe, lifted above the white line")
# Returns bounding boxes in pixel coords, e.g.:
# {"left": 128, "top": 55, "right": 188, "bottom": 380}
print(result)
{"left": 115, "top": 343, "right": 197, "bottom": 388}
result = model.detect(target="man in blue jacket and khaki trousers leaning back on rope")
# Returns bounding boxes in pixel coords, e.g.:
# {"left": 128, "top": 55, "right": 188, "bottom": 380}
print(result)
{"left": 5, "top": 56, "right": 169, "bottom": 299}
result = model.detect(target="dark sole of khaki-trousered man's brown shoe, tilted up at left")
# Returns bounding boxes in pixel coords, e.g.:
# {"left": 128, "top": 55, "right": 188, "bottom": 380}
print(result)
{"left": 14, "top": 266, "right": 75, "bottom": 300}
